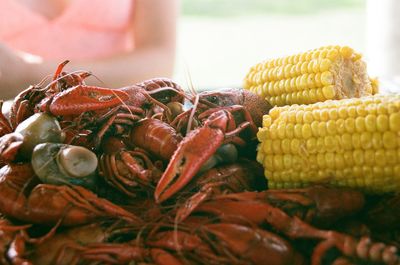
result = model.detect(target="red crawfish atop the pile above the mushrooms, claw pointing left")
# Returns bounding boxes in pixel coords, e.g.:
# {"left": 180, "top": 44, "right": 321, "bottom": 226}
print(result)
{"left": 39, "top": 79, "right": 184, "bottom": 149}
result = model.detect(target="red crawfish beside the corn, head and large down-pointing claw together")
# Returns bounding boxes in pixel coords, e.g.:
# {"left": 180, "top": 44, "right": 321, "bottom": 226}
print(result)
{"left": 155, "top": 89, "right": 271, "bottom": 202}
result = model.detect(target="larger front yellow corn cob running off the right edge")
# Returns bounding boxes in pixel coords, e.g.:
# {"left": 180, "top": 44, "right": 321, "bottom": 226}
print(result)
{"left": 257, "top": 94, "right": 400, "bottom": 193}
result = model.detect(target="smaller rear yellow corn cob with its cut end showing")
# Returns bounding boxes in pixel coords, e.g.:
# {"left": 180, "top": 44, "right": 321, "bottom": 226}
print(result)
{"left": 243, "top": 46, "right": 372, "bottom": 106}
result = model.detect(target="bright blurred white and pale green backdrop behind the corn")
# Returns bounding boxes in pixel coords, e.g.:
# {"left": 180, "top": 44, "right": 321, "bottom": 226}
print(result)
{"left": 175, "top": 0, "right": 400, "bottom": 89}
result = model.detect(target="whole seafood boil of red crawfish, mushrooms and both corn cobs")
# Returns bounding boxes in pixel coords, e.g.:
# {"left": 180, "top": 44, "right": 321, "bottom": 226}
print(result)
{"left": 0, "top": 46, "right": 400, "bottom": 265}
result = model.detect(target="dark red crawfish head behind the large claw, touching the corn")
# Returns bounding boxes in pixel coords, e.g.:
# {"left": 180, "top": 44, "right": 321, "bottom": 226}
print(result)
{"left": 199, "top": 88, "right": 272, "bottom": 127}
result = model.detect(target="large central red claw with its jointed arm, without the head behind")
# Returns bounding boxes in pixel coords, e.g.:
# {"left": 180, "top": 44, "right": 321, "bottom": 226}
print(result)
{"left": 155, "top": 106, "right": 266, "bottom": 202}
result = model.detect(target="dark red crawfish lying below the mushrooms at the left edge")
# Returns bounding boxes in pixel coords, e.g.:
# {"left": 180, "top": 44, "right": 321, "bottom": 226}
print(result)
{"left": 0, "top": 164, "right": 142, "bottom": 225}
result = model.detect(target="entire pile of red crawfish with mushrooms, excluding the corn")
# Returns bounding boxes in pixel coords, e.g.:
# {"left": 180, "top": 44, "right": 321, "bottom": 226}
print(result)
{"left": 0, "top": 62, "right": 400, "bottom": 265}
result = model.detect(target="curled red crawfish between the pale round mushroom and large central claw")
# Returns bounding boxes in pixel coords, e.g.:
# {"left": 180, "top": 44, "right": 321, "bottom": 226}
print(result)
{"left": 99, "top": 118, "right": 182, "bottom": 197}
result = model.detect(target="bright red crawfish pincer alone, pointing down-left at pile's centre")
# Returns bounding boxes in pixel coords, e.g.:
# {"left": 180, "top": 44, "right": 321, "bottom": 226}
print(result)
{"left": 154, "top": 126, "right": 224, "bottom": 203}
